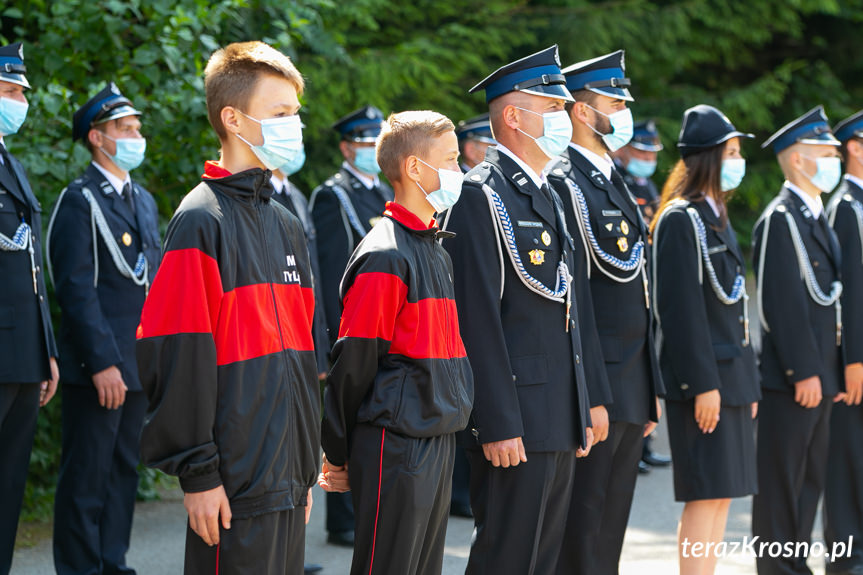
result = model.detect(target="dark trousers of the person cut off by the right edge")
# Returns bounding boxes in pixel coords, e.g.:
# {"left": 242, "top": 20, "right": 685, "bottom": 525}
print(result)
{"left": 824, "top": 403, "right": 863, "bottom": 572}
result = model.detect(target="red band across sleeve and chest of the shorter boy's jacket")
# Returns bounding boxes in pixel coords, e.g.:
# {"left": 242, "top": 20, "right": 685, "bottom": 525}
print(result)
{"left": 339, "top": 272, "right": 467, "bottom": 359}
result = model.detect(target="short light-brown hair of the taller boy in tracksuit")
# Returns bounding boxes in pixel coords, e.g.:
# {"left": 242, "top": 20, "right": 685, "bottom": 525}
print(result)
{"left": 204, "top": 41, "right": 305, "bottom": 140}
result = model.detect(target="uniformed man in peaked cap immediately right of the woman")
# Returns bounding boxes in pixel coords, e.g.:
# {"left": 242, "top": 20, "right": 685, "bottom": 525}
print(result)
{"left": 752, "top": 106, "right": 848, "bottom": 575}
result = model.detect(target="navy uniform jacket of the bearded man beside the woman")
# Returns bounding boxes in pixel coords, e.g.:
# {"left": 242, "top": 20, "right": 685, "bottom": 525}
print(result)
{"left": 549, "top": 146, "right": 664, "bottom": 424}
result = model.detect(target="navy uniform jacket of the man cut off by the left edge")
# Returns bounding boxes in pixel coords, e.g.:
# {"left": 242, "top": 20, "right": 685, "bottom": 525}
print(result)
{"left": 0, "top": 144, "right": 57, "bottom": 384}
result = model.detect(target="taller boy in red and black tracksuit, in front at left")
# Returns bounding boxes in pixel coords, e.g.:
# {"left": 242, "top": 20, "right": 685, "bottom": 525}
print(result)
{"left": 137, "top": 42, "right": 320, "bottom": 575}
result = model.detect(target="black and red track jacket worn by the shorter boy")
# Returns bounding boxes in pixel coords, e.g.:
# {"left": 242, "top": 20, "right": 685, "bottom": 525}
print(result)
{"left": 322, "top": 202, "right": 473, "bottom": 465}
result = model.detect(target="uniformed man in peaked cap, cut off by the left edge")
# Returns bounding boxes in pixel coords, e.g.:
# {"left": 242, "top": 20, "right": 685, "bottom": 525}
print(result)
{"left": 0, "top": 43, "right": 57, "bottom": 575}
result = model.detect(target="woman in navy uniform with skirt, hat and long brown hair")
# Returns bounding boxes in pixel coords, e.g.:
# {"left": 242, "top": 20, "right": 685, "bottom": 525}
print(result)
{"left": 651, "top": 105, "right": 760, "bottom": 575}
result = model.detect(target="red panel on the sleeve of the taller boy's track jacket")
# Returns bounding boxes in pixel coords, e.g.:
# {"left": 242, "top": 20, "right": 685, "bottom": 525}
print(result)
{"left": 137, "top": 248, "right": 223, "bottom": 339}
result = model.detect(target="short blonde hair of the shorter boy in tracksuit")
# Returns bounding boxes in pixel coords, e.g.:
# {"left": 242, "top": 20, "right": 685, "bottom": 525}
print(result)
{"left": 375, "top": 110, "right": 455, "bottom": 182}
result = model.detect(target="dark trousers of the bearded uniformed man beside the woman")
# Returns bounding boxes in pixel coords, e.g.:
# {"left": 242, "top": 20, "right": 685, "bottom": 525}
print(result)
{"left": 557, "top": 422, "right": 644, "bottom": 575}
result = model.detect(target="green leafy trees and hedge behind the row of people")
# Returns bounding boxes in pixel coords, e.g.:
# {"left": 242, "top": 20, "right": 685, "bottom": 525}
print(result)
{"left": 0, "top": 0, "right": 863, "bottom": 518}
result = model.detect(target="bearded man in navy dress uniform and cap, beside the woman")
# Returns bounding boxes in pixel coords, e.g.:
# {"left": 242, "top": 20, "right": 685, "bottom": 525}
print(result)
{"left": 549, "top": 50, "right": 664, "bottom": 575}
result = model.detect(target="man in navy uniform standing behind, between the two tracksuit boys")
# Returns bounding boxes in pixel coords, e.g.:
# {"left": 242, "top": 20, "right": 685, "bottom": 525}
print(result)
{"left": 309, "top": 106, "right": 393, "bottom": 547}
